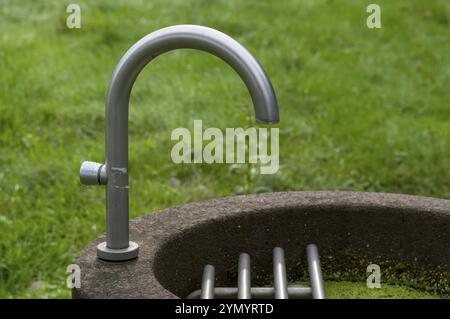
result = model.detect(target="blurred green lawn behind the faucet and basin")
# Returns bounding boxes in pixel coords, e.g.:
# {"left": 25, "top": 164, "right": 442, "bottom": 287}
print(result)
{"left": 0, "top": 0, "right": 450, "bottom": 297}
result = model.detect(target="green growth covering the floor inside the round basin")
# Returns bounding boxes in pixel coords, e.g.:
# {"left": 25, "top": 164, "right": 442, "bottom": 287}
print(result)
{"left": 325, "top": 281, "right": 441, "bottom": 299}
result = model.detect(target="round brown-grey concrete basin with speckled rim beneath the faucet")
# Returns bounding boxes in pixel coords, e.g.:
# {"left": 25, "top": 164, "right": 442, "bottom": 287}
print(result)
{"left": 73, "top": 192, "right": 450, "bottom": 298}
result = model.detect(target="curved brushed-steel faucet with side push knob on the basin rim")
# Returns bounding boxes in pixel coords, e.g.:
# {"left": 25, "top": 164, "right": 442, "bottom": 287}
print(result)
{"left": 80, "top": 25, "right": 278, "bottom": 261}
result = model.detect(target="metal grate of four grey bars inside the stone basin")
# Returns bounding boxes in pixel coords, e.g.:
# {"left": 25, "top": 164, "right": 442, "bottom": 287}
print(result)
{"left": 187, "top": 244, "right": 325, "bottom": 299}
